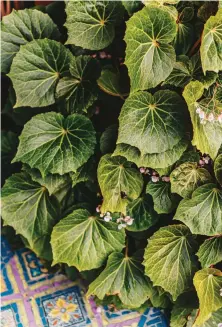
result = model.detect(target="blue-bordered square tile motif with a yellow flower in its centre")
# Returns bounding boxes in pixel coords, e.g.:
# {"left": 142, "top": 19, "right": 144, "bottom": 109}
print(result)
{"left": 36, "top": 286, "right": 91, "bottom": 327}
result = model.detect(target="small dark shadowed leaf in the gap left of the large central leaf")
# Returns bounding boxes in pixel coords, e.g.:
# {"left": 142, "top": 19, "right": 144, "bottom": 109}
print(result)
{"left": 100, "top": 124, "right": 118, "bottom": 154}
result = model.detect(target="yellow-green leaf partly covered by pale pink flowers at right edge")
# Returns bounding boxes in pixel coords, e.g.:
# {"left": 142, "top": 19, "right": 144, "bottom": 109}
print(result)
{"left": 183, "top": 81, "right": 222, "bottom": 159}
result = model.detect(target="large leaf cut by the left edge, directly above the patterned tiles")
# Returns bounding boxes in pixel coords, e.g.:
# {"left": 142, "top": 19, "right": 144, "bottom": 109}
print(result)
{"left": 2, "top": 173, "right": 59, "bottom": 248}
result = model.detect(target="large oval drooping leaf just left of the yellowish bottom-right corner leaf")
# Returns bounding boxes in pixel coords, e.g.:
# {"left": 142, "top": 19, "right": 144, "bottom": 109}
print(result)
{"left": 143, "top": 225, "right": 197, "bottom": 301}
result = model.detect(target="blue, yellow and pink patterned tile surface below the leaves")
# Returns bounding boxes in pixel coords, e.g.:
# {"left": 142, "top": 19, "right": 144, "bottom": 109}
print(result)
{"left": 0, "top": 237, "right": 167, "bottom": 327}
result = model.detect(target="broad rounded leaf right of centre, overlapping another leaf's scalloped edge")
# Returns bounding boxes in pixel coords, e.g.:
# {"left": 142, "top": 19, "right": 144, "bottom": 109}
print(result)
{"left": 117, "top": 90, "right": 185, "bottom": 155}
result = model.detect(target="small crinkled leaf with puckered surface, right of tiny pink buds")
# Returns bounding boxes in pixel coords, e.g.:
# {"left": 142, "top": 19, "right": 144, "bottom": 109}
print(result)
{"left": 170, "top": 162, "right": 213, "bottom": 199}
